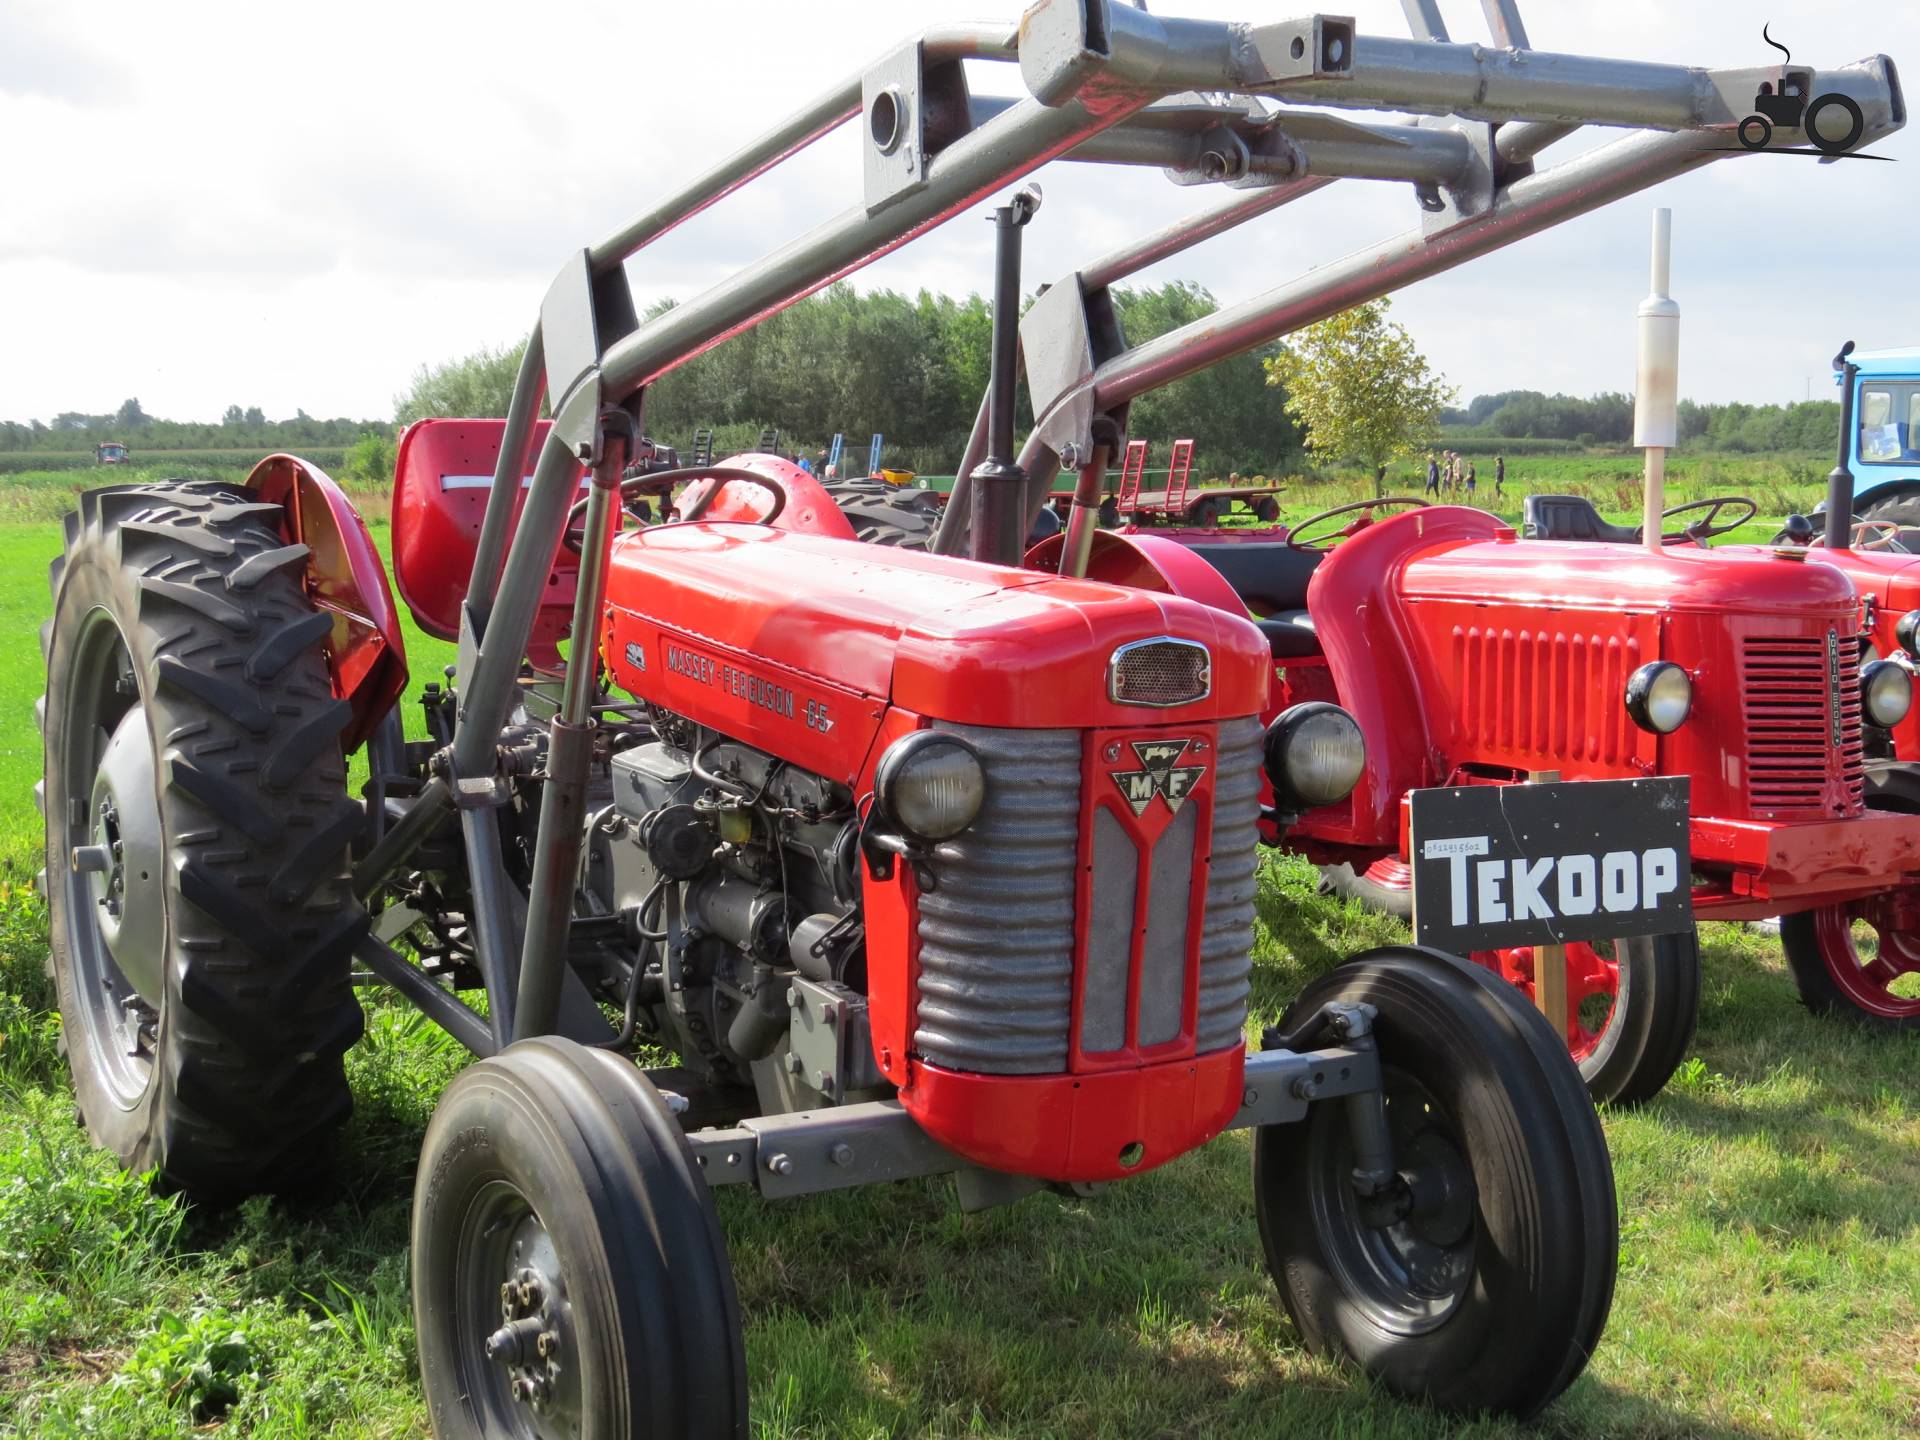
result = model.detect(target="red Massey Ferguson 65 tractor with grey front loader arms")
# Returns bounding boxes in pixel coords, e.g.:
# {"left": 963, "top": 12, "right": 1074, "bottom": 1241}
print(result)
{"left": 42, "top": 0, "right": 1899, "bottom": 1440}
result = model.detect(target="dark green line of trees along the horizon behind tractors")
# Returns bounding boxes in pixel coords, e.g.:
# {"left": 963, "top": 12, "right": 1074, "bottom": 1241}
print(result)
{"left": 0, "top": 280, "right": 1837, "bottom": 480}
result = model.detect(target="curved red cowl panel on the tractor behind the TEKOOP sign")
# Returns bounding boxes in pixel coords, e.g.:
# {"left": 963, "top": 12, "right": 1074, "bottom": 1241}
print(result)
{"left": 1308, "top": 505, "right": 1511, "bottom": 849}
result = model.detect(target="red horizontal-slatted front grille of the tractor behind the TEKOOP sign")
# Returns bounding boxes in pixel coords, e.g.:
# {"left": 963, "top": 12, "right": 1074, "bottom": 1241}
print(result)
{"left": 1740, "top": 636, "right": 1862, "bottom": 814}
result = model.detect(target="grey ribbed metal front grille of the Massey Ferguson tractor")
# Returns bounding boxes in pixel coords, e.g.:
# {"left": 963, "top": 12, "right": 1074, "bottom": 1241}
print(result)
{"left": 914, "top": 718, "right": 1261, "bottom": 1075}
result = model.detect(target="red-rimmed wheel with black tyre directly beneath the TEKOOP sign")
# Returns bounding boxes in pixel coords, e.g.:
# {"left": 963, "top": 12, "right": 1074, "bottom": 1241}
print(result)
{"left": 1471, "top": 931, "right": 1699, "bottom": 1104}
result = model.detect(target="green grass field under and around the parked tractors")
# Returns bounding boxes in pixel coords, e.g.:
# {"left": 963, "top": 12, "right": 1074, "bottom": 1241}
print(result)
{"left": 0, "top": 468, "right": 1920, "bottom": 1440}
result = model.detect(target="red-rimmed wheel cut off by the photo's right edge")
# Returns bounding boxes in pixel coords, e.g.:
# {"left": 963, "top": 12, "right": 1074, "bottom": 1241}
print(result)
{"left": 1780, "top": 898, "right": 1920, "bottom": 1029}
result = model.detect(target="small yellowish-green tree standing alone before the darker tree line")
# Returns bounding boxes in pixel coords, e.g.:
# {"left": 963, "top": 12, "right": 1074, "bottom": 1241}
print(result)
{"left": 1265, "top": 300, "right": 1453, "bottom": 481}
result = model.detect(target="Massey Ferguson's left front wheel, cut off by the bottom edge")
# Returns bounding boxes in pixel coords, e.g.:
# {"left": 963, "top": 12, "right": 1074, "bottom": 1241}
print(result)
{"left": 413, "top": 1039, "right": 747, "bottom": 1440}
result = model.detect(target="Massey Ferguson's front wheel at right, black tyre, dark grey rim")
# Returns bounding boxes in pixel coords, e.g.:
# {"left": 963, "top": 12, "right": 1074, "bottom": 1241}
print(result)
{"left": 1254, "top": 947, "right": 1619, "bottom": 1417}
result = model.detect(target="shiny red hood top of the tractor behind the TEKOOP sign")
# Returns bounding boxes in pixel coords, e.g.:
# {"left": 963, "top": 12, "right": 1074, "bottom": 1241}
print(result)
{"left": 1404, "top": 540, "right": 1855, "bottom": 614}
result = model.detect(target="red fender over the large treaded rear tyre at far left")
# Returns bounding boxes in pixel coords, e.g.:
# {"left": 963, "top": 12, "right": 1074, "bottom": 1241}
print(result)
{"left": 246, "top": 455, "right": 407, "bottom": 755}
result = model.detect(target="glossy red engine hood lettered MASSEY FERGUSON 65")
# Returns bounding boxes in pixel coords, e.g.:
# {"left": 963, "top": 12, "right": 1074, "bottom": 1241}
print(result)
{"left": 607, "top": 524, "right": 1273, "bottom": 774}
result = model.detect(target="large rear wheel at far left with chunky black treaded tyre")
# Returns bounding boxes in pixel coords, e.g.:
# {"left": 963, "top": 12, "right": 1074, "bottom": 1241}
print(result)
{"left": 40, "top": 482, "right": 367, "bottom": 1200}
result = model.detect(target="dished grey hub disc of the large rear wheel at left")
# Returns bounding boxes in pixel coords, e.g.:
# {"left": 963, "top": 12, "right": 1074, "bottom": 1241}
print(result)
{"left": 73, "top": 705, "right": 167, "bottom": 1008}
